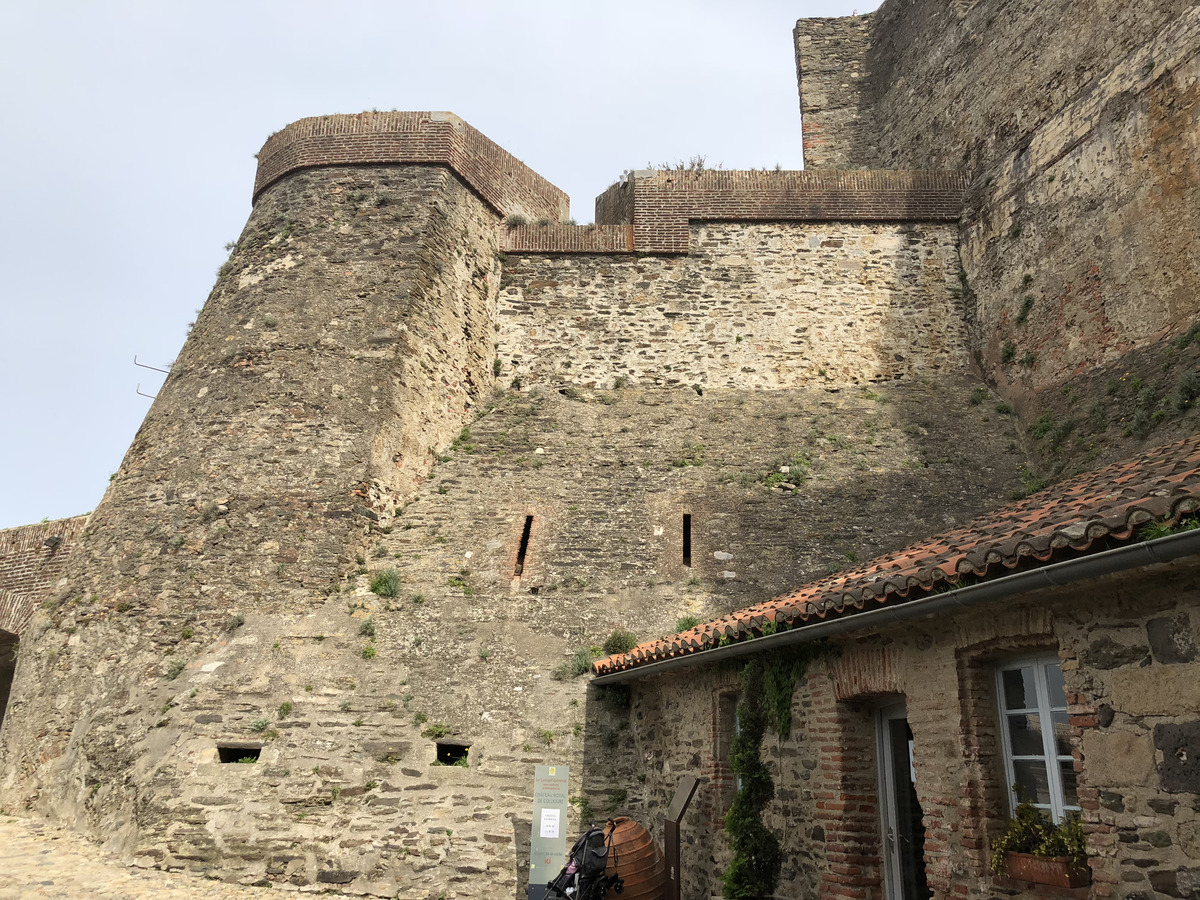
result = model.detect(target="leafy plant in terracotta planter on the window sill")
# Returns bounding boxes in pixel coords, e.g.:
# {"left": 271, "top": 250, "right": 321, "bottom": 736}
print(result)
{"left": 991, "top": 803, "right": 1092, "bottom": 888}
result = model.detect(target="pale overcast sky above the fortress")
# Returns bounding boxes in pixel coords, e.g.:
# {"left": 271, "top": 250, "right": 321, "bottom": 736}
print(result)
{"left": 0, "top": 0, "right": 878, "bottom": 528}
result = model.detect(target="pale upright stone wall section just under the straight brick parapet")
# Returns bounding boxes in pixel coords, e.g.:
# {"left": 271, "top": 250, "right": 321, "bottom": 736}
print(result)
{"left": 498, "top": 222, "right": 968, "bottom": 389}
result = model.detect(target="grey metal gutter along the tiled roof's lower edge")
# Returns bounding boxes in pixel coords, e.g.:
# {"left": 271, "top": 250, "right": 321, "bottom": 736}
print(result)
{"left": 592, "top": 529, "right": 1200, "bottom": 685}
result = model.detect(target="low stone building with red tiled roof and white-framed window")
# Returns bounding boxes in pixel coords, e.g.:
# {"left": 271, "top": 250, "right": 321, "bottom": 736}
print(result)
{"left": 596, "top": 438, "right": 1200, "bottom": 898}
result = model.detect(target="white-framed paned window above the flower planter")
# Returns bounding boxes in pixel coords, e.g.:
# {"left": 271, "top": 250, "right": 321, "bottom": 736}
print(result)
{"left": 996, "top": 654, "right": 1079, "bottom": 822}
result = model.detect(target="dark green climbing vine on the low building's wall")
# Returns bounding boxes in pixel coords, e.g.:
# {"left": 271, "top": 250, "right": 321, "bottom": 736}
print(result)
{"left": 722, "top": 642, "right": 829, "bottom": 900}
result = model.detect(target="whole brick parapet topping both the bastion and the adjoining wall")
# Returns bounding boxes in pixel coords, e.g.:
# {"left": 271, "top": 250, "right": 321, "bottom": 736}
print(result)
{"left": 254, "top": 112, "right": 966, "bottom": 253}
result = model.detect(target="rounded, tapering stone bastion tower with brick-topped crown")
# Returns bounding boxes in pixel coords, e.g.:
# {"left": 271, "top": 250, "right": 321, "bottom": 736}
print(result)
{"left": 0, "top": 113, "right": 585, "bottom": 896}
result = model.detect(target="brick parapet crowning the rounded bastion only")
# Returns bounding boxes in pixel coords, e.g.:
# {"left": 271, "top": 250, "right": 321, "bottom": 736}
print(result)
{"left": 254, "top": 112, "right": 570, "bottom": 222}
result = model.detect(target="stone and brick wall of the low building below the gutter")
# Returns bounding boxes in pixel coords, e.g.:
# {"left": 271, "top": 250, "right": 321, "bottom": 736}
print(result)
{"left": 629, "top": 564, "right": 1200, "bottom": 898}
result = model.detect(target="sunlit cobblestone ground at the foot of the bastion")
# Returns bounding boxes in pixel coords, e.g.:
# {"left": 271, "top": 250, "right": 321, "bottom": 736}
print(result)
{"left": 0, "top": 815, "right": 348, "bottom": 900}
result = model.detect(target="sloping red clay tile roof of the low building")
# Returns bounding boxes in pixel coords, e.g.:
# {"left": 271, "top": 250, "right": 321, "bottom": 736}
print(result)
{"left": 593, "top": 436, "right": 1200, "bottom": 674}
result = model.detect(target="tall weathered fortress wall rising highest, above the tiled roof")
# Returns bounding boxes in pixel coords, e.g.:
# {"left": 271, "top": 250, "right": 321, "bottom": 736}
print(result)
{"left": 796, "top": 0, "right": 1200, "bottom": 482}
